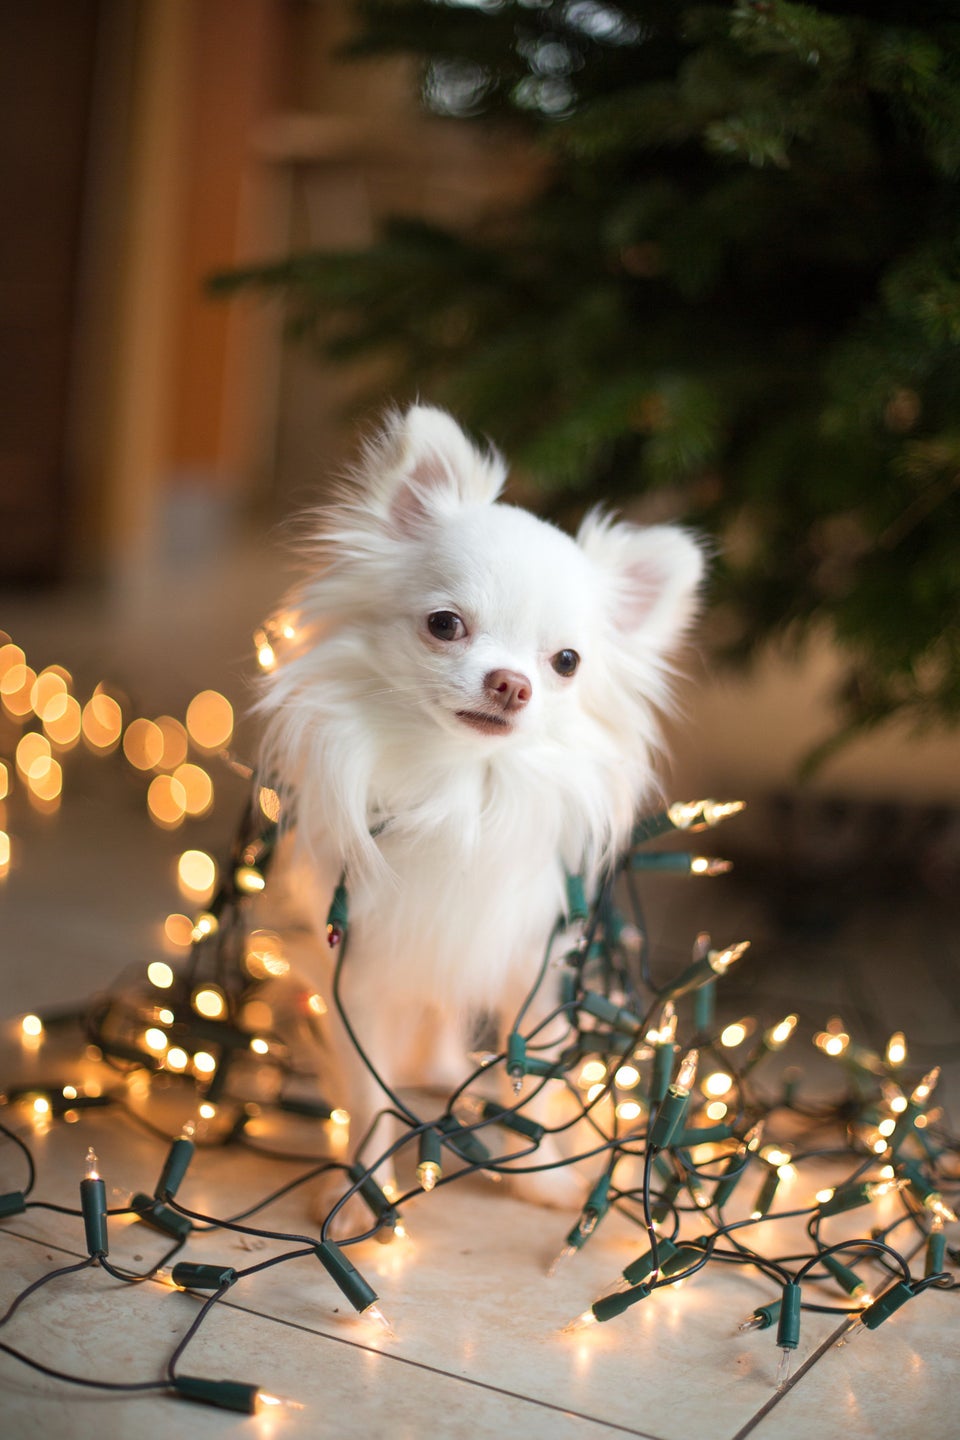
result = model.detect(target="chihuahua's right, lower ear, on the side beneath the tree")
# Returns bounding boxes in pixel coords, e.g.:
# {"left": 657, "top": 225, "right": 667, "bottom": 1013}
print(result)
{"left": 577, "top": 511, "right": 705, "bottom": 651}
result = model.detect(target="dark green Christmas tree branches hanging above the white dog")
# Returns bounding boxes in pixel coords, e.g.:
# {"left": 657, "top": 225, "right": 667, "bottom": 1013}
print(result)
{"left": 214, "top": 0, "right": 960, "bottom": 760}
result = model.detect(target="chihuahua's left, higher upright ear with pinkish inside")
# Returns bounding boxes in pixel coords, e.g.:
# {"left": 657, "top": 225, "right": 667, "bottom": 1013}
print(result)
{"left": 370, "top": 405, "right": 507, "bottom": 534}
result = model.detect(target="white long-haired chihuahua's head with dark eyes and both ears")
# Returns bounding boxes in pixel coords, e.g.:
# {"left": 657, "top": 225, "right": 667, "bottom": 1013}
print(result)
{"left": 343, "top": 409, "right": 701, "bottom": 755}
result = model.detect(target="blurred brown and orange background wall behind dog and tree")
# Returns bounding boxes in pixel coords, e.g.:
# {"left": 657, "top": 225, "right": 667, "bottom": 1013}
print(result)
{"left": 0, "top": 0, "right": 960, "bottom": 829}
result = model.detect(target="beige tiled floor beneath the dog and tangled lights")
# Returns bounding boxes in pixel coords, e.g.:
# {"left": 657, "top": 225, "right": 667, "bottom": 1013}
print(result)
{"left": 0, "top": 541, "right": 960, "bottom": 1440}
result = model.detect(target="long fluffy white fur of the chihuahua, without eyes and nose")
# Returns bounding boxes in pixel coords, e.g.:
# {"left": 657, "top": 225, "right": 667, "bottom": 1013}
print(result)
{"left": 262, "top": 406, "right": 702, "bottom": 1215}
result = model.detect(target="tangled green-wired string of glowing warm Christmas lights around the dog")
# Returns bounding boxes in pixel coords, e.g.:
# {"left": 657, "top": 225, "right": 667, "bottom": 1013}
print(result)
{"left": 0, "top": 619, "right": 960, "bottom": 1411}
